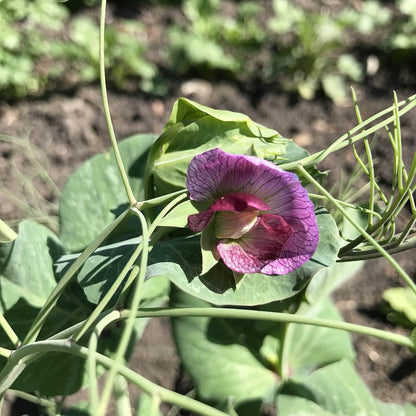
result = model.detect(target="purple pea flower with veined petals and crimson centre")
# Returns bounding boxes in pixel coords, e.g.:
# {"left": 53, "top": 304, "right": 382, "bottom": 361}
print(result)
{"left": 186, "top": 148, "right": 319, "bottom": 275}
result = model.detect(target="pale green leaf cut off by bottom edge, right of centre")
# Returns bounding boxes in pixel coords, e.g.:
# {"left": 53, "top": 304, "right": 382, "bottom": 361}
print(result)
{"left": 277, "top": 360, "right": 381, "bottom": 416}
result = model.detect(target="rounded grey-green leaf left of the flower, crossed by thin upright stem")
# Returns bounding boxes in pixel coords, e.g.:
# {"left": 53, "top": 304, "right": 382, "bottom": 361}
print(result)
{"left": 59, "top": 134, "right": 155, "bottom": 252}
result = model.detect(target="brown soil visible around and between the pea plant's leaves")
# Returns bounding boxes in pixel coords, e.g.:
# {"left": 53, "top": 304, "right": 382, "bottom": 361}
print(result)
{"left": 0, "top": 4, "right": 416, "bottom": 416}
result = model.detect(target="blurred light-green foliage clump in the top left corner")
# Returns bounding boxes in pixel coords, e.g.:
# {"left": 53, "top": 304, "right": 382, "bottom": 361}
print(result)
{"left": 0, "top": 0, "right": 162, "bottom": 96}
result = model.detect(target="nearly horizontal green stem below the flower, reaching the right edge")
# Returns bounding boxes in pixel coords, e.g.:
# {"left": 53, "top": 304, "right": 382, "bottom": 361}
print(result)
{"left": 132, "top": 308, "right": 416, "bottom": 350}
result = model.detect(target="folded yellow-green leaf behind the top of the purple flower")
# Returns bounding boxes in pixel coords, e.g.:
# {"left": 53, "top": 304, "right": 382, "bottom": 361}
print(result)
{"left": 146, "top": 98, "right": 307, "bottom": 197}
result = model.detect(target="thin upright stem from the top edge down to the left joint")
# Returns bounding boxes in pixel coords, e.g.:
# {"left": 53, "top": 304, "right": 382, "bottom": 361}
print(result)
{"left": 99, "top": 0, "right": 136, "bottom": 206}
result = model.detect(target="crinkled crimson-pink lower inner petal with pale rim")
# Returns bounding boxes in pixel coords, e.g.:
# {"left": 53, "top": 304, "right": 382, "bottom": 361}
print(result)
{"left": 217, "top": 214, "right": 293, "bottom": 273}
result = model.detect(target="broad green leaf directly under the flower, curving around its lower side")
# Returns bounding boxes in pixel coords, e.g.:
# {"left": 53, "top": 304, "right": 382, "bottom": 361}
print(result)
{"left": 150, "top": 209, "right": 338, "bottom": 305}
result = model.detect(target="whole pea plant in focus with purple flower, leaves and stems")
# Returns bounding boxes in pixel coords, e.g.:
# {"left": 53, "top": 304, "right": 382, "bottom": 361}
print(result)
{"left": 0, "top": 1, "right": 416, "bottom": 416}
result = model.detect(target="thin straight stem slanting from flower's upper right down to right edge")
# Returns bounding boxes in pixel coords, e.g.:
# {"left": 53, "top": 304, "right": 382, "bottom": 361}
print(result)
{"left": 298, "top": 165, "right": 416, "bottom": 294}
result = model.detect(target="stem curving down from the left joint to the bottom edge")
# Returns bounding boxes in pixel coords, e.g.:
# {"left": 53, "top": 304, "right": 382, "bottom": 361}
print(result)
{"left": 98, "top": 208, "right": 149, "bottom": 415}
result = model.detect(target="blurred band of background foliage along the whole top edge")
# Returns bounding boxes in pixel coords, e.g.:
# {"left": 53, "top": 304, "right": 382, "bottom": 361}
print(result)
{"left": 0, "top": 0, "right": 416, "bottom": 102}
